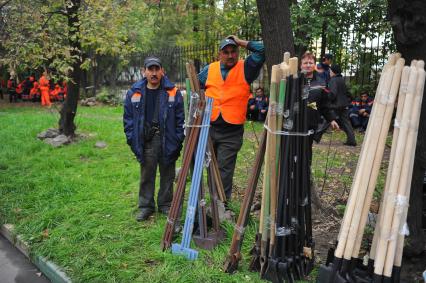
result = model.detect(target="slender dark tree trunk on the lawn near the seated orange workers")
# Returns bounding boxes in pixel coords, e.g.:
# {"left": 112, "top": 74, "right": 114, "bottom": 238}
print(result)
{"left": 59, "top": 0, "right": 81, "bottom": 136}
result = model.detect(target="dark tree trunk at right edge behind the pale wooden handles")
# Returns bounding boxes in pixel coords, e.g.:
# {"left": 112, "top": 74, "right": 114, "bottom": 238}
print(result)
{"left": 388, "top": 0, "right": 426, "bottom": 256}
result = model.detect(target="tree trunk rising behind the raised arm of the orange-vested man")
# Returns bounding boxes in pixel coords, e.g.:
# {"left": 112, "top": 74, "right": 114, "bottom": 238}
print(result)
{"left": 256, "top": 0, "right": 295, "bottom": 73}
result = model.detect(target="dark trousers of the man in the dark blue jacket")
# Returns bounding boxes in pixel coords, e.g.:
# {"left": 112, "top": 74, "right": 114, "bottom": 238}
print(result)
{"left": 139, "top": 134, "right": 175, "bottom": 211}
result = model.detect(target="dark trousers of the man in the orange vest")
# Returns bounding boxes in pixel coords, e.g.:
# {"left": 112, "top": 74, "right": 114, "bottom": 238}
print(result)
{"left": 210, "top": 123, "right": 244, "bottom": 200}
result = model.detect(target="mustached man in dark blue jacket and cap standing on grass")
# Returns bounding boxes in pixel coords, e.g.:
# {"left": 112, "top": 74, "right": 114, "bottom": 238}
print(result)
{"left": 123, "top": 56, "right": 185, "bottom": 221}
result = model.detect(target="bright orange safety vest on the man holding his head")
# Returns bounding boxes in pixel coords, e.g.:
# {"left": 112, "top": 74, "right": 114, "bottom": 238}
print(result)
{"left": 206, "top": 60, "right": 250, "bottom": 125}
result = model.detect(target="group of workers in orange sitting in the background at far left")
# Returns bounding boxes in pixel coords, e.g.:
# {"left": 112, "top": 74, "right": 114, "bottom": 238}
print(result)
{"left": 0, "top": 73, "right": 67, "bottom": 107}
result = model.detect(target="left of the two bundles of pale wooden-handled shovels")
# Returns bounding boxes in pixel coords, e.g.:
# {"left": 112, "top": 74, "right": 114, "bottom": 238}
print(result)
{"left": 318, "top": 55, "right": 403, "bottom": 282}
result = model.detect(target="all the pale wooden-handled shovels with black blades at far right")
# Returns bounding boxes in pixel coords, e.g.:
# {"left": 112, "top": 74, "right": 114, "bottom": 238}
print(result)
{"left": 317, "top": 54, "right": 425, "bottom": 283}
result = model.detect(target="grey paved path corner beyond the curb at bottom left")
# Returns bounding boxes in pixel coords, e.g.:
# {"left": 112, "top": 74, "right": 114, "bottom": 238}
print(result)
{"left": 0, "top": 235, "right": 50, "bottom": 283}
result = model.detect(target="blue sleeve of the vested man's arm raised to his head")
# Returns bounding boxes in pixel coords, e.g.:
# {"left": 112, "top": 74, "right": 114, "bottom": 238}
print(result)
{"left": 244, "top": 41, "right": 265, "bottom": 84}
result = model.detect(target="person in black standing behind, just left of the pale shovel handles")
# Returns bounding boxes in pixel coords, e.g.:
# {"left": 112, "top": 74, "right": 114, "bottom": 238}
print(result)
{"left": 328, "top": 65, "right": 356, "bottom": 146}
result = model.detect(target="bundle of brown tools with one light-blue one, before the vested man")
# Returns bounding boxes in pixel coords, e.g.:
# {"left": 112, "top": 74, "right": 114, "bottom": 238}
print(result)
{"left": 161, "top": 64, "right": 225, "bottom": 259}
